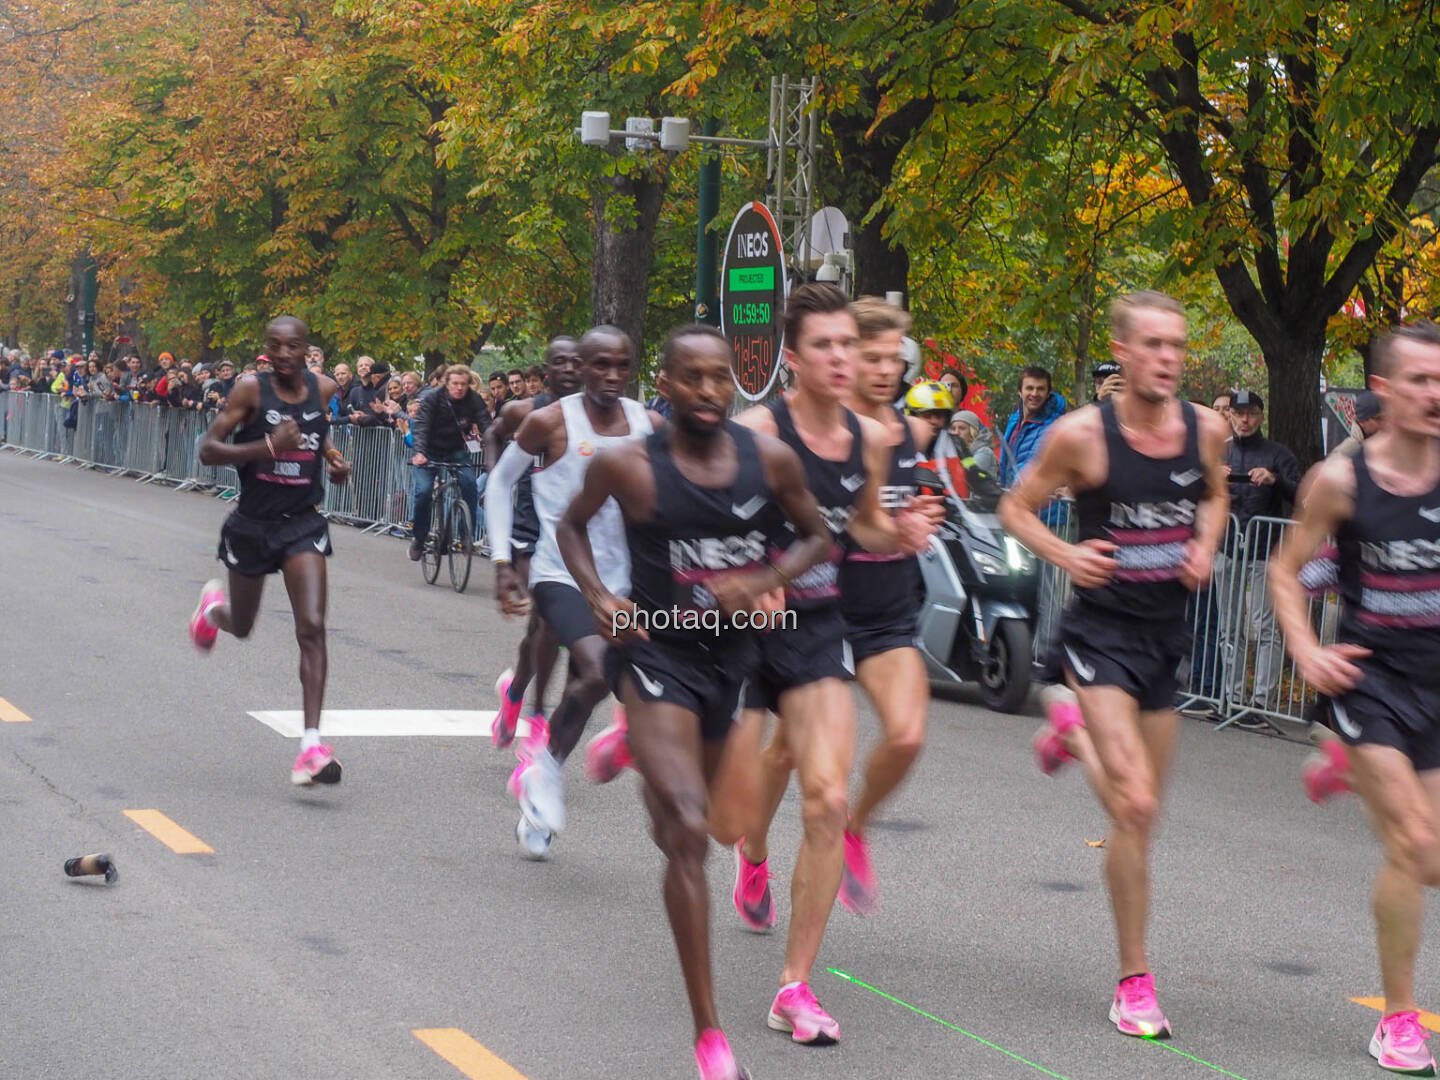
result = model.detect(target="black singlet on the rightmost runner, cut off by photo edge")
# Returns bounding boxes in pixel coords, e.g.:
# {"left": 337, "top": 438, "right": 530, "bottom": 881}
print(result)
{"left": 1335, "top": 446, "right": 1440, "bottom": 685}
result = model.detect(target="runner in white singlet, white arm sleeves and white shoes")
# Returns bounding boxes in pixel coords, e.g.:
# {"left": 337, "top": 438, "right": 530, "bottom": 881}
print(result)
{"left": 485, "top": 327, "right": 660, "bottom": 860}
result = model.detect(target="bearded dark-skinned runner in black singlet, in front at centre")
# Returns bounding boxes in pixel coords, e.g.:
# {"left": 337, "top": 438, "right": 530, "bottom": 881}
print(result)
{"left": 557, "top": 325, "right": 831, "bottom": 1080}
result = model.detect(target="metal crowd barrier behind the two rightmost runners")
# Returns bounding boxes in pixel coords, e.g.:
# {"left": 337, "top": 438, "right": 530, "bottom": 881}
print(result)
{"left": 1034, "top": 500, "right": 1339, "bottom": 734}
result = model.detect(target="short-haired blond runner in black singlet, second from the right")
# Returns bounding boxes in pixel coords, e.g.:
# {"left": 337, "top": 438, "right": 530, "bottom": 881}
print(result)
{"left": 999, "top": 292, "right": 1228, "bottom": 1038}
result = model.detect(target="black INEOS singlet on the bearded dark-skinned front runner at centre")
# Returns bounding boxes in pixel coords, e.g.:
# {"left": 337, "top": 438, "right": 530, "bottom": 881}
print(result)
{"left": 625, "top": 420, "right": 779, "bottom": 642}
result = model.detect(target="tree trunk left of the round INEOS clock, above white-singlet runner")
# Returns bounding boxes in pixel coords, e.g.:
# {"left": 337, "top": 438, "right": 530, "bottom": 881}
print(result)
{"left": 590, "top": 173, "right": 665, "bottom": 386}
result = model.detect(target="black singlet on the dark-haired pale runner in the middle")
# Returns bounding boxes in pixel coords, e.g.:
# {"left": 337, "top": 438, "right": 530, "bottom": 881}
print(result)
{"left": 766, "top": 397, "right": 865, "bottom": 611}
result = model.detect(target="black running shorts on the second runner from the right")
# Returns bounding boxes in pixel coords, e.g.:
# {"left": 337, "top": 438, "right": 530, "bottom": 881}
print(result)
{"left": 1050, "top": 608, "right": 1191, "bottom": 713}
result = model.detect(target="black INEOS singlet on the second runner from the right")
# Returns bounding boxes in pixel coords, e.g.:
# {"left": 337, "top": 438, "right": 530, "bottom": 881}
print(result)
{"left": 1074, "top": 399, "right": 1205, "bottom": 622}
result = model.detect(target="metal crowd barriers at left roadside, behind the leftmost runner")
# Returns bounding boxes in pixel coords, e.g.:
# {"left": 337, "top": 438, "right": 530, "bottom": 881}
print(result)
{"left": 0, "top": 390, "right": 410, "bottom": 531}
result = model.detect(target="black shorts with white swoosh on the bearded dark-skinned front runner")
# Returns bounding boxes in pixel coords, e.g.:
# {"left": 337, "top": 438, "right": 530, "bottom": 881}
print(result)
{"left": 605, "top": 635, "right": 759, "bottom": 743}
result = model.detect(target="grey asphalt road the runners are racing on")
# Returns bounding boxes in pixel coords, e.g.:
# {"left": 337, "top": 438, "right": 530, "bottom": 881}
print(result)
{"left": 0, "top": 452, "right": 1437, "bottom": 1080}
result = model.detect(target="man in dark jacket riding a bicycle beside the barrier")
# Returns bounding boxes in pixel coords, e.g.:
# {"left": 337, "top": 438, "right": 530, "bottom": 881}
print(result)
{"left": 410, "top": 364, "right": 490, "bottom": 563}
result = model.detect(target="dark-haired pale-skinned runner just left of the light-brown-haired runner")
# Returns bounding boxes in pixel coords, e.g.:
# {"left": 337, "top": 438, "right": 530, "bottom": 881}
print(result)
{"left": 726, "top": 284, "right": 940, "bottom": 1045}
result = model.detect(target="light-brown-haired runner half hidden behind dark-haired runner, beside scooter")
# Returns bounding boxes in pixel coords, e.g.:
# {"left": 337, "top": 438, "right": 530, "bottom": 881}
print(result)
{"left": 840, "top": 297, "right": 933, "bottom": 914}
